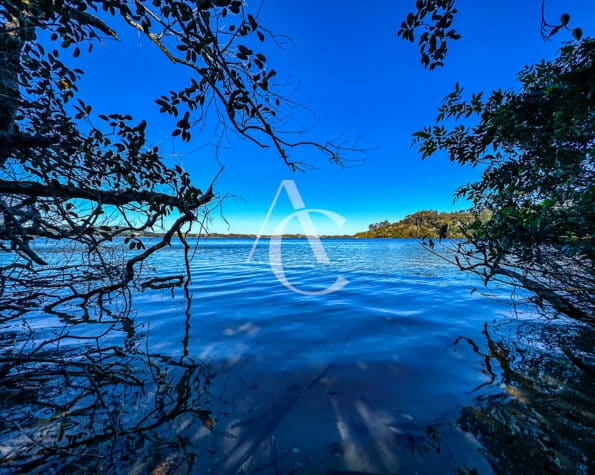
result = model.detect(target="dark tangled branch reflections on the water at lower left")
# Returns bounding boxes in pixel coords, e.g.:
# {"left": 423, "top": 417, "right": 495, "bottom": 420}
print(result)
{"left": 0, "top": 300, "right": 218, "bottom": 474}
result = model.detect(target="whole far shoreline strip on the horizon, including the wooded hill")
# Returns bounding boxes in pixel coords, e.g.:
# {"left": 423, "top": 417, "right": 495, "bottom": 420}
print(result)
{"left": 129, "top": 210, "right": 476, "bottom": 239}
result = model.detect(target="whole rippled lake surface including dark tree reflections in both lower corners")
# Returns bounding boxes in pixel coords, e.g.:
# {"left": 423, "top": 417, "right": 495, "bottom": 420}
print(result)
{"left": 0, "top": 240, "right": 594, "bottom": 475}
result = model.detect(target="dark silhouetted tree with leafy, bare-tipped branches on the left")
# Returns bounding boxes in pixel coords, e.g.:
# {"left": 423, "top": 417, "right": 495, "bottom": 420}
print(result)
{"left": 0, "top": 0, "right": 340, "bottom": 314}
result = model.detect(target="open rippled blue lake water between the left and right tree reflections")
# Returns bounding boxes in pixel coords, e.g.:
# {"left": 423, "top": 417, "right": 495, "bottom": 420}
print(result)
{"left": 135, "top": 239, "right": 511, "bottom": 473}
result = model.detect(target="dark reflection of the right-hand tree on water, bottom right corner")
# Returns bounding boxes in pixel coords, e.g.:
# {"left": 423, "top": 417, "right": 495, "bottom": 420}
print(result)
{"left": 458, "top": 321, "right": 595, "bottom": 474}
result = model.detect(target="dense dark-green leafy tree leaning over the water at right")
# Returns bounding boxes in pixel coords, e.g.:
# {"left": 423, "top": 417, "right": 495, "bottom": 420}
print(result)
{"left": 415, "top": 39, "right": 595, "bottom": 323}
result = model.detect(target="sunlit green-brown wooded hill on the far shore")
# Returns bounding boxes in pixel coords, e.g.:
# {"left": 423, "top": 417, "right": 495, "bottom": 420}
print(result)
{"left": 355, "top": 210, "right": 475, "bottom": 238}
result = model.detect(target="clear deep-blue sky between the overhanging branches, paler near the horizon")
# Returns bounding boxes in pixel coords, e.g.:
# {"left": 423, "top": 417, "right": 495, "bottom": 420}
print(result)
{"left": 69, "top": 0, "right": 595, "bottom": 234}
